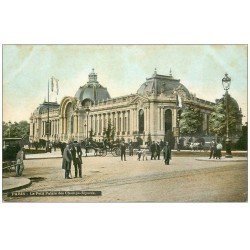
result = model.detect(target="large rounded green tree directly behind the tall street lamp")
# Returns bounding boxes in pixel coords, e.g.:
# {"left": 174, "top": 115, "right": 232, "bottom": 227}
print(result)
{"left": 209, "top": 95, "right": 242, "bottom": 136}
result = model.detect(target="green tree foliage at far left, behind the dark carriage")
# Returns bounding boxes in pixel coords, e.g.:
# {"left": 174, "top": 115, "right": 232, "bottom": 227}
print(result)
{"left": 3, "top": 121, "right": 30, "bottom": 138}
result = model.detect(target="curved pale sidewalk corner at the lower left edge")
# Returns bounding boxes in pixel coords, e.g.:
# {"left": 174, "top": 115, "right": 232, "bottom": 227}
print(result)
{"left": 2, "top": 177, "right": 31, "bottom": 193}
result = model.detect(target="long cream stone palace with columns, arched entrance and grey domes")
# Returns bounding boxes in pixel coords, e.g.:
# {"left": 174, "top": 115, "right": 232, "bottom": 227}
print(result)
{"left": 30, "top": 70, "right": 214, "bottom": 142}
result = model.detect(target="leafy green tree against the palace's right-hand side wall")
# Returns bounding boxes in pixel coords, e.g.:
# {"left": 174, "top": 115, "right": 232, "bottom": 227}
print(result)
{"left": 179, "top": 107, "right": 203, "bottom": 136}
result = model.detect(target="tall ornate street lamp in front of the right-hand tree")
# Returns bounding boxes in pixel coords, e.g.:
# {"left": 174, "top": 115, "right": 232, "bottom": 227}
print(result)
{"left": 222, "top": 74, "right": 233, "bottom": 158}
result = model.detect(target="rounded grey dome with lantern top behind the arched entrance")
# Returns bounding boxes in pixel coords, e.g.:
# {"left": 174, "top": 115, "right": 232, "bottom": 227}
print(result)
{"left": 75, "top": 69, "right": 110, "bottom": 102}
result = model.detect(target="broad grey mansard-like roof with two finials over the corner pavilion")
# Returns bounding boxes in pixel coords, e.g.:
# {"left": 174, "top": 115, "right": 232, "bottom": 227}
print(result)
{"left": 137, "top": 70, "right": 189, "bottom": 96}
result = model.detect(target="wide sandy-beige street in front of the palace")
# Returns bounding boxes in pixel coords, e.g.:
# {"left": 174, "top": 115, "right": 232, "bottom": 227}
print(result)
{"left": 3, "top": 155, "right": 248, "bottom": 202}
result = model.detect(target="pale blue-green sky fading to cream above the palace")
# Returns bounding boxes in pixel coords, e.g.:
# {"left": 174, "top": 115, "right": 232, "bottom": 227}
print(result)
{"left": 3, "top": 45, "right": 247, "bottom": 123}
